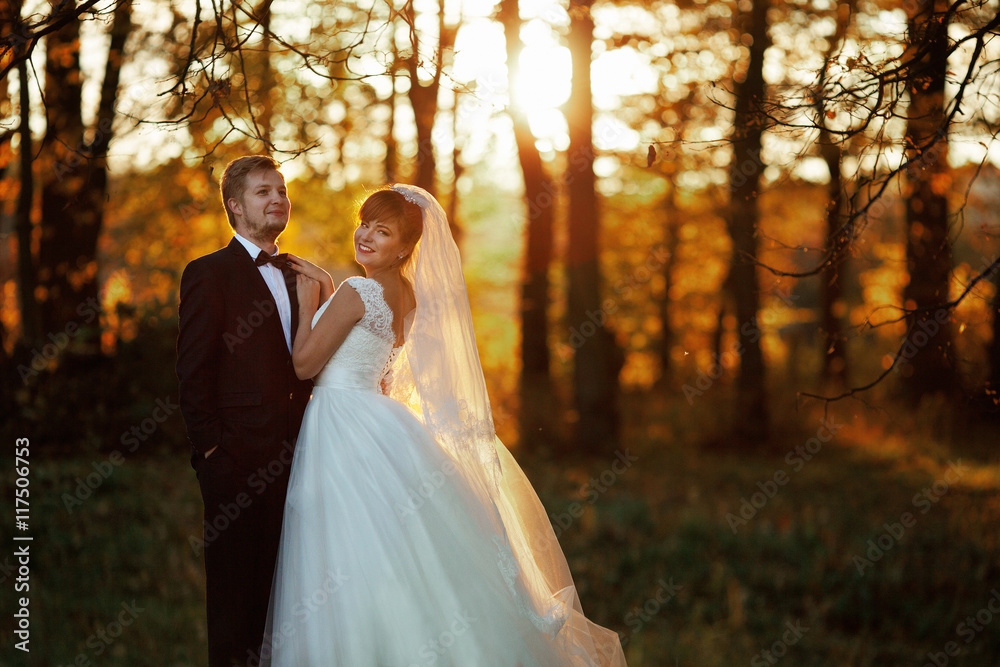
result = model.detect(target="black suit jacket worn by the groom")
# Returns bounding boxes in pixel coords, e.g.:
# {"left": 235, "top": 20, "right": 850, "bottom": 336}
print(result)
{"left": 177, "top": 237, "right": 312, "bottom": 474}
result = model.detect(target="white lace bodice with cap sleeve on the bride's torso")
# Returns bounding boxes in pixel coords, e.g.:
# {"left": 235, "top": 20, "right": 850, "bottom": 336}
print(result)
{"left": 312, "top": 276, "right": 396, "bottom": 391}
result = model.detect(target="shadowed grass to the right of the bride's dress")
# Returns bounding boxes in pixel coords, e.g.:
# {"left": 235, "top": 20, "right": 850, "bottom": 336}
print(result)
{"left": 529, "top": 388, "right": 1000, "bottom": 666}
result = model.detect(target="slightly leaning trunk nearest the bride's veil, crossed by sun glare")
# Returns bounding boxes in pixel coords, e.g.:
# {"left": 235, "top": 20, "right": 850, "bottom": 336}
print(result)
{"left": 500, "top": 0, "right": 558, "bottom": 445}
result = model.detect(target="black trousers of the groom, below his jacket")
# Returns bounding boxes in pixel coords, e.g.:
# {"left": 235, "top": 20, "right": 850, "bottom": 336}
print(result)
{"left": 196, "top": 447, "right": 290, "bottom": 667}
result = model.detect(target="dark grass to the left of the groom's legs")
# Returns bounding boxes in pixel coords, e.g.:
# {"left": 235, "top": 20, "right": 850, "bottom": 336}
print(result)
{"left": 0, "top": 451, "right": 206, "bottom": 665}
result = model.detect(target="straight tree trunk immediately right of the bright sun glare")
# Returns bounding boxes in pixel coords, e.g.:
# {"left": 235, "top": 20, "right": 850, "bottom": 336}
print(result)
{"left": 566, "top": 0, "right": 624, "bottom": 453}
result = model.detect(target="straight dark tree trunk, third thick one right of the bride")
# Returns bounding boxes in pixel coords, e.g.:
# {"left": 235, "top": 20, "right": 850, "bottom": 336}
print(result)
{"left": 728, "top": 0, "right": 770, "bottom": 443}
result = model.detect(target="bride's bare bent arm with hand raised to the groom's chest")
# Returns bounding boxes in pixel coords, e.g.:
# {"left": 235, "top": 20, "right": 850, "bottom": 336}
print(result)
{"left": 292, "top": 275, "right": 365, "bottom": 380}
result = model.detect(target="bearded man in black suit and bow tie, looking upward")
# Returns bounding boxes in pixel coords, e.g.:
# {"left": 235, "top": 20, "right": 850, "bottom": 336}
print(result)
{"left": 177, "top": 155, "right": 312, "bottom": 667}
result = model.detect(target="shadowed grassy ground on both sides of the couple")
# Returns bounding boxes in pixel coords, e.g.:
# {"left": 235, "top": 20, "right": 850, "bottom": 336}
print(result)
{"left": 0, "top": 390, "right": 1000, "bottom": 667}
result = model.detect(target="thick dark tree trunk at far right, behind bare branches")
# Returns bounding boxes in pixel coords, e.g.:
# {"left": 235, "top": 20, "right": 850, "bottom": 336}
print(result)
{"left": 903, "top": 0, "right": 958, "bottom": 400}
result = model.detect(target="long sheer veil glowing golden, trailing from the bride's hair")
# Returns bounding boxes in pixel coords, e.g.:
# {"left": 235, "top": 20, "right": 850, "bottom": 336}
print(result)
{"left": 385, "top": 184, "right": 625, "bottom": 666}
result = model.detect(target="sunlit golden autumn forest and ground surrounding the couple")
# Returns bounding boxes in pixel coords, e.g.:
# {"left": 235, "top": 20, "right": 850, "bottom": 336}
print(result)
{"left": 0, "top": 0, "right": 1000, "bottom": 666}
